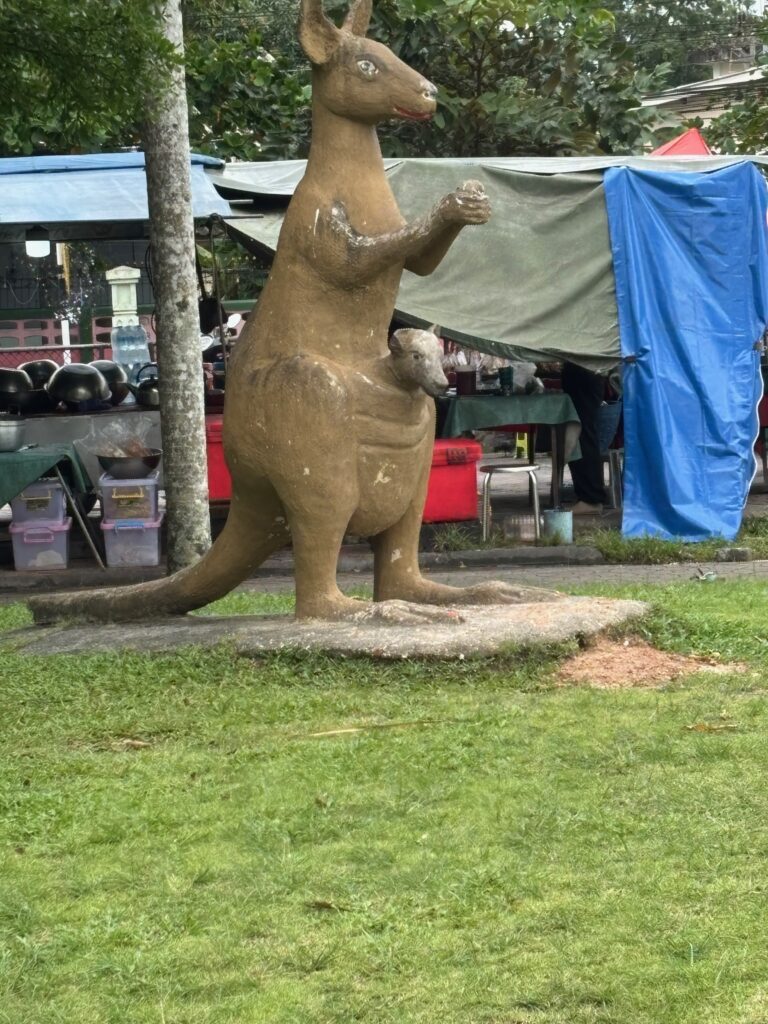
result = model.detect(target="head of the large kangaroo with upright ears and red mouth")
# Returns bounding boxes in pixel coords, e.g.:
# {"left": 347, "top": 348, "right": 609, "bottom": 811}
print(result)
{"left": 299, "top": 0, "right": 437, "bottom": 124}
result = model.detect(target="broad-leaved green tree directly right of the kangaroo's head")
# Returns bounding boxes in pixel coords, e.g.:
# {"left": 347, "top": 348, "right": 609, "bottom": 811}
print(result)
{"left": 364, "top": 0, "right": 655, "bottom": 156}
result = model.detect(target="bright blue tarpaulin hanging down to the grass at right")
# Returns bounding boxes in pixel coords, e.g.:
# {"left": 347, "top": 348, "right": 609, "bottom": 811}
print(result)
{"left": 605, "top": 163, "right": 768, "bottom": 541}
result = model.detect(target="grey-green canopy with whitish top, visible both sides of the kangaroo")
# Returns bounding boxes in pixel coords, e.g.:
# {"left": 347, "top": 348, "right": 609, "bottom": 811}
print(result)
{"left": 214, "top": 157, "right": 768, "bottom": 369}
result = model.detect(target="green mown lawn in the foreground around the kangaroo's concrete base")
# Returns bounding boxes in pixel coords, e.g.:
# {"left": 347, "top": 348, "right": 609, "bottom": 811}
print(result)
{"left": 0, "top": 581, "right": 768, "bottom": 1024}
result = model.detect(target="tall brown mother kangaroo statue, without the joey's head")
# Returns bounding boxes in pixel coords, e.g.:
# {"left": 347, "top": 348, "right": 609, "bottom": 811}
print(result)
{"left": 30, "top": 0, "right": 556, "bottom": 622}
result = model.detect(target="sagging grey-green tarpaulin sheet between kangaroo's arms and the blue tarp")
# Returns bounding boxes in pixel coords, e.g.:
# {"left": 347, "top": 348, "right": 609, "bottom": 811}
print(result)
{"left": 390, "top": 162, "right": 618, "bottom": 364}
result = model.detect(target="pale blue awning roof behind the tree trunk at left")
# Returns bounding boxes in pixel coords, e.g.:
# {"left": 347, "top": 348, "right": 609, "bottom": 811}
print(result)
{"left": 0, "top": 153, "right": 230, "bottom": 242}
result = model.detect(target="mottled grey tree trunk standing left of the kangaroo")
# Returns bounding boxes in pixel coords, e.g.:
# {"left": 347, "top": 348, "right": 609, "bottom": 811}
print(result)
{"left": 142, "top": 0, "right": 211, "bottom": 571}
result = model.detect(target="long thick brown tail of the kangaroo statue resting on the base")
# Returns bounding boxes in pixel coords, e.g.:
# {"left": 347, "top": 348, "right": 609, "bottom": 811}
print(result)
{"left": 28, "top": 497, "right": 288, "bottom": 623}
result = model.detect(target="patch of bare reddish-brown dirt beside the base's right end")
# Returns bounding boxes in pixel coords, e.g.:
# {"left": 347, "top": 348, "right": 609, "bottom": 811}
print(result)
{"left": 558, "top": 637, "right": 745, "bottom": 689}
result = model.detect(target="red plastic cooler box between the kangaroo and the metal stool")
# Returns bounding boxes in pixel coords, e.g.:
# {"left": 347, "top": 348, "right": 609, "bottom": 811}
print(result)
{"left": 422, "top": 437, "right": 482, "bottom": 522}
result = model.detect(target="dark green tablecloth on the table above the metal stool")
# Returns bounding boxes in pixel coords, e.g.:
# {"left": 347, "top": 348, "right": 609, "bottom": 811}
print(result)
{"left": 439, "top": 391, "right": 582, "bottom": 459}
